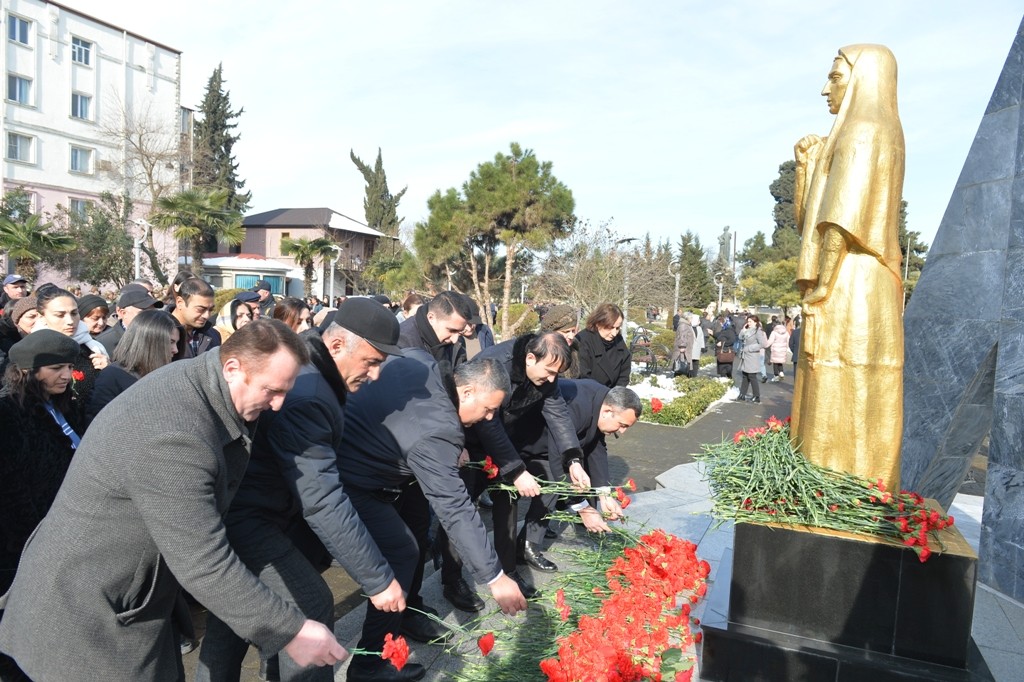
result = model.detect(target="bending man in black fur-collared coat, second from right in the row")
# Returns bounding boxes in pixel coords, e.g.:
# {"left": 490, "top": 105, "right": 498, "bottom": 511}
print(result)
{"left": 441, "top": 332, "right": 590, "bottom": 610}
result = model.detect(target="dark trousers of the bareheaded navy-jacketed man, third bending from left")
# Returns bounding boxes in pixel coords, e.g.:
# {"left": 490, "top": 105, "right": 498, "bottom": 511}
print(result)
{"left": 345, "top": 482, "right": 430, "bottom": 651}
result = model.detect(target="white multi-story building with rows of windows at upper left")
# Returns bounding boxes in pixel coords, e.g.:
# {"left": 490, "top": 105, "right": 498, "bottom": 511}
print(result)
{"left": 0, "top": 0, "right": 185, "bottom": 276}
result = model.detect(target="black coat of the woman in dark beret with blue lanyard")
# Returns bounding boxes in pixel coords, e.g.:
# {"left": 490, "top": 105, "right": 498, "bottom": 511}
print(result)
{"left": 0, "top": 395, "right": 82, "bottom": 594}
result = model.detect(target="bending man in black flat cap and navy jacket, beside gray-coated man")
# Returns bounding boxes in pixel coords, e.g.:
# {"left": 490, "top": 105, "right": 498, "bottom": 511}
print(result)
{"left": 196, "top": 298, "right": 405, "bottom": 682}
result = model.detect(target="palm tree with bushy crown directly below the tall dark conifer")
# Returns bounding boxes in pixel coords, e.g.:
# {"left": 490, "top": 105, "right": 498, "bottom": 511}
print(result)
{"left": 152, "top": 188, "right": 246, "bottom": 276}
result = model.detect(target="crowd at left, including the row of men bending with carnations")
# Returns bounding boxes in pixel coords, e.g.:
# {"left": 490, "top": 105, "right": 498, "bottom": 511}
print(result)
{"left": 0, "top": 272, "right": 642, "bottom": 681}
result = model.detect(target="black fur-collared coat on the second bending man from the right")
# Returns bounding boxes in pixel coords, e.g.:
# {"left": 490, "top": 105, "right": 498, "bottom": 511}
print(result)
{"left": 467, "top": 334, "right": 581, "bottom": 476}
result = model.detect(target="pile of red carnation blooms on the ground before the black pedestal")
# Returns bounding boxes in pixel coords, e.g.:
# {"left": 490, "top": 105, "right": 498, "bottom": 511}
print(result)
{"left": 541, "top": 530, "right": 711, "bottom": 682}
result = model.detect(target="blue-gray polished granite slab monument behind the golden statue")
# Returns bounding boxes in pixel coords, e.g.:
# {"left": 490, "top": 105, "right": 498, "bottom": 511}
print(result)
{"left": 902, "top": 17, "right": 1024, "bottom": 601}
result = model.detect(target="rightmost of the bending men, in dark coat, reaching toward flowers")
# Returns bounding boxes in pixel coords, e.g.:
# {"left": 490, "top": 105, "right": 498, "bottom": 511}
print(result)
{"left": 519, "top": 379, "right": 643, "bottom": 532}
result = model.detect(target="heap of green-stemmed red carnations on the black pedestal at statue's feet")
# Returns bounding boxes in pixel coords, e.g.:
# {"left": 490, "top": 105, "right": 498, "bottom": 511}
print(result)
{"left": 698, "top": 417, "right": 953, "bottom": 561}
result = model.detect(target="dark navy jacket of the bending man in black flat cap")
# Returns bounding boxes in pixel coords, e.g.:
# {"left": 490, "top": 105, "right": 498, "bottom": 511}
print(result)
{"left": 225, "top": 330, "right": 394, "bottom": 595}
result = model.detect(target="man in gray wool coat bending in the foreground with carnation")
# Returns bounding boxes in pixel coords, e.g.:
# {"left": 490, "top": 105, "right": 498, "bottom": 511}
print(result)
{"left": 0, "top": 319, "right": 347, "bottom": 682}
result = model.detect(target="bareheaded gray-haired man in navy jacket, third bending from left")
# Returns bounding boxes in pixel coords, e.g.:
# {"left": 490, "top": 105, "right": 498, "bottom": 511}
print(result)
{"left": 338, "top": 348, "right": 526, "bottom": 680}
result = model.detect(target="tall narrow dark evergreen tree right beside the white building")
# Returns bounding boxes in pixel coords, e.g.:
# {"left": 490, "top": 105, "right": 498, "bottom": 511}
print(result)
{"left": 193, "top": 65, "right": 252, "bottom": 214}
